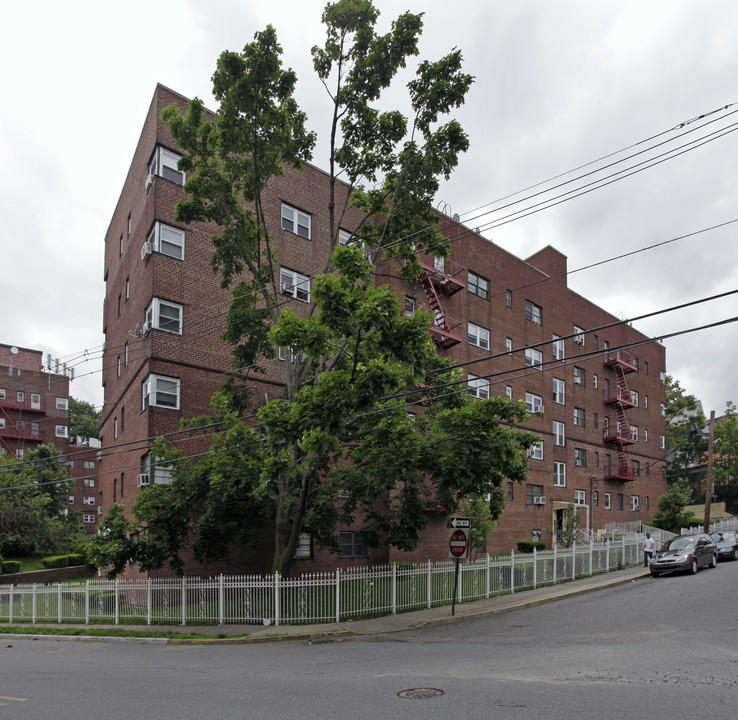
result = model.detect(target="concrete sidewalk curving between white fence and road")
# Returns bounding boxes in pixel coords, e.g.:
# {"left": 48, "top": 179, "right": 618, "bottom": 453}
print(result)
{"left": 0, "top": 566, "right": 649, "bottom": 645}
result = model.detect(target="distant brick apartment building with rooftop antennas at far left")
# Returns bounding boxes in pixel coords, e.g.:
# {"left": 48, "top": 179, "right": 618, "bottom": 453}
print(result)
{"left": 0, "top": 344, "right": 99, "bottom": 533}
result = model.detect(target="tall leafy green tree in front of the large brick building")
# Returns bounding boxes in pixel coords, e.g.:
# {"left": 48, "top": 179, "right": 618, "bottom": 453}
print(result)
{"left": 96, "top": 0, "right": 537, "bottom": 574}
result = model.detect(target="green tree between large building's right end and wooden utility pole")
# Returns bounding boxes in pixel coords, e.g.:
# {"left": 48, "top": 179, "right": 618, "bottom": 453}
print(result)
{"left": 665, "top": 375, "right": 708, "bottom": 481}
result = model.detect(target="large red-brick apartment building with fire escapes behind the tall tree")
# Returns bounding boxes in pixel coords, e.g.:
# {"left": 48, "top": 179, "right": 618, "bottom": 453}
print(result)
{"left": 97, "top": 85, "right": 665, "bottom": 573}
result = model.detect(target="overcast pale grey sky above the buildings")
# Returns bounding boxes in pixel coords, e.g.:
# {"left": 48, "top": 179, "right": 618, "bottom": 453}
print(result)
{"left": 0, "top": 0, "right": 738, "bottom": 414}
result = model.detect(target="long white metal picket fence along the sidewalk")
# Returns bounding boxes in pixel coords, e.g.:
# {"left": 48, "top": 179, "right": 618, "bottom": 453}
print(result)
{"left": 0, "top": 538, "right": 642, "bottom": 625}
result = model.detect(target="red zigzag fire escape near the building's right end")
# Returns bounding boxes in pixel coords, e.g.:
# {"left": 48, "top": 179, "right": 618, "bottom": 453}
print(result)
{"left": 603, "top": 350, "right": 638, "bottom": 482}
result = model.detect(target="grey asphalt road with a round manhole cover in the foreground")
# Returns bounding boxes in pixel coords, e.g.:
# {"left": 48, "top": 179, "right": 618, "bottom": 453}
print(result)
{"left": 0, "top": 563, "right": 738, "bottom": 720}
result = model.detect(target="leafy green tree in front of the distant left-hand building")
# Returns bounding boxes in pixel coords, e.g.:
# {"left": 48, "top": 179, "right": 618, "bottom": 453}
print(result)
{"left": 0, "top": 444, "right": 85, "bottom": 556}
